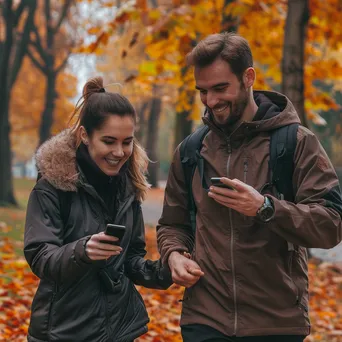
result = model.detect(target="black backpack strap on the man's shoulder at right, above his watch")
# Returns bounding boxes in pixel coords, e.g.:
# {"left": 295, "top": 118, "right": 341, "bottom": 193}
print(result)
{"left": 269, "top": 123, "right": 299, "bottom": 202}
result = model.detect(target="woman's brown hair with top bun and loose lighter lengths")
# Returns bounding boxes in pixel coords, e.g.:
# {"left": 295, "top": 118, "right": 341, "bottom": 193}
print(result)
{"left": 69, "top": 77, "right": 150, "bottom": 201}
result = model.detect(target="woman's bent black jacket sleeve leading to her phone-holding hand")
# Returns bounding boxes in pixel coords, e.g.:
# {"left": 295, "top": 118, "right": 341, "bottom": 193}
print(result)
{"left": 24, "top": 186, "right": 99, "bottom": 285}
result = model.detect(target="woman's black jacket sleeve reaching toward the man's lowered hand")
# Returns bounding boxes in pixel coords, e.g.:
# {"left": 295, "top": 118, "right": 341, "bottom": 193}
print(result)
{"left": 125, "top": 201, "right": 173, "bottom": 289}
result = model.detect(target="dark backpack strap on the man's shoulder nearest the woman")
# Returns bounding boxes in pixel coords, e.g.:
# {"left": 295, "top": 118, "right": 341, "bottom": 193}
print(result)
{"left": 179, "top": 126, "right": 209, "bottom": 235}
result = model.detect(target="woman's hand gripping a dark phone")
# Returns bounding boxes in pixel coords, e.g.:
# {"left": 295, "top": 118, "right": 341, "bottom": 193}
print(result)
{"left": 85, "top": 232, "right": 122, "bottom": 260}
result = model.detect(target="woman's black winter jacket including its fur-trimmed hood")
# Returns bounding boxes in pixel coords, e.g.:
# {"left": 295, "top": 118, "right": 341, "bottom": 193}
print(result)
{"left": 24, "top": 131, "right": 172, "bottom": 342}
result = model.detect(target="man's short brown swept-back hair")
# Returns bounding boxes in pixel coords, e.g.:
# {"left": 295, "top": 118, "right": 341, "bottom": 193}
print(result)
{"left": 186, "top": 32, "right": 253, "bottom": 81}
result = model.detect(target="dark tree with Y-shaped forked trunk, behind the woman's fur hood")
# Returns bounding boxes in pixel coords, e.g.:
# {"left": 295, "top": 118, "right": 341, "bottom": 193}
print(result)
{"left": 28, "top": 0, "right": 73, "bottom": 145}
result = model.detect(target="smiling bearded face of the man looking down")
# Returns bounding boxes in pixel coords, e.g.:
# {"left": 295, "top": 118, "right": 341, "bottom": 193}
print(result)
{"left": 195, "top": 58, "right": 248, "bottom": 125}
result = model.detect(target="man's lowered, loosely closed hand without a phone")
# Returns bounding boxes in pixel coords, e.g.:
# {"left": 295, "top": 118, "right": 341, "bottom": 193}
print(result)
{"left": 169, "top": 252, "right": 204, "bottom": 287}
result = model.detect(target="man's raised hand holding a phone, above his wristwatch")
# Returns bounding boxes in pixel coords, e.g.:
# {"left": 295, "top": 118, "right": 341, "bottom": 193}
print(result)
{"left": 209, "top": 177, "right": 265, "bottom": 216}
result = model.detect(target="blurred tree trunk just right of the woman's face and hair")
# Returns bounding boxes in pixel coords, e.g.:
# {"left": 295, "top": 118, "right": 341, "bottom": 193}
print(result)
{"left": 146, "top": 89, "right": 161, "bottom": 188}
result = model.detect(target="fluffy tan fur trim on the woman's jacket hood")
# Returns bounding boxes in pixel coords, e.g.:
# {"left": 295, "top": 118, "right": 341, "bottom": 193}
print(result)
{"left": 36, "top": 129, "right": 79, "bottom": 191}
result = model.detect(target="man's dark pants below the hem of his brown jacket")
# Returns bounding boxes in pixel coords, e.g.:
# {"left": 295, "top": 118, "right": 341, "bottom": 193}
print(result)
{"left": 182, "top": 324, "right": 305, "bottom": 342}
